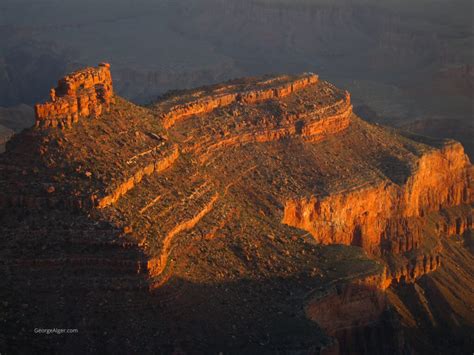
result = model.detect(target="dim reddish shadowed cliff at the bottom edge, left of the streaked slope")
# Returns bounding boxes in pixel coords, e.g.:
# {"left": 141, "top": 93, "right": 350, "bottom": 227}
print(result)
{"left": 305, "top": 276, "right": 412, "bottom": 354}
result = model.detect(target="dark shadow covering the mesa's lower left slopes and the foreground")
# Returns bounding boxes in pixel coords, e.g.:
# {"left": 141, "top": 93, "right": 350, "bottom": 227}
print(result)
{"left": 0, "top": 204, "right": 399, "bottom": 354}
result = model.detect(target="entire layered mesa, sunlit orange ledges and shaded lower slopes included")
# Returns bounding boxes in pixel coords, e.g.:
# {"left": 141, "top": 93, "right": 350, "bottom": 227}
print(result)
{"left": 0, "top": 64, "right": 474, "bottom": 354}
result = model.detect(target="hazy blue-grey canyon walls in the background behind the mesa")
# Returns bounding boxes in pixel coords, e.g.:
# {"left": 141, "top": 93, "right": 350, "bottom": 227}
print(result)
{"left": 0, "top": 0, "right": 474, "bottom": 158}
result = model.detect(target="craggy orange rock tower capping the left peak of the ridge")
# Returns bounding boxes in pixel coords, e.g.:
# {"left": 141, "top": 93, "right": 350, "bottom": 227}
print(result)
{"left": 35, "top": 63, "right": 114, "bottom": 128}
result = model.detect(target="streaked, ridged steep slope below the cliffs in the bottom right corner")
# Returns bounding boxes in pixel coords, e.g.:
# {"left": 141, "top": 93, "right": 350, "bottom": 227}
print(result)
{"left": 388, "top": 232, "right": 474, "bottom": 353}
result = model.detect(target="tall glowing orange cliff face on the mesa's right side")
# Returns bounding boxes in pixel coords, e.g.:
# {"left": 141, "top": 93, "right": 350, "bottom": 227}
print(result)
{"left": 283, "top": 143, "right": 474, "bottom": 255}
